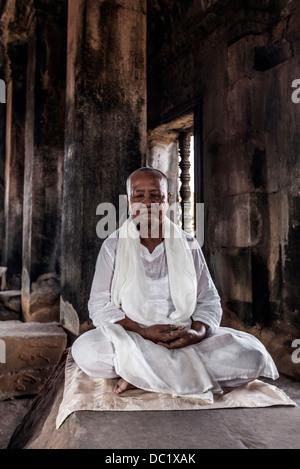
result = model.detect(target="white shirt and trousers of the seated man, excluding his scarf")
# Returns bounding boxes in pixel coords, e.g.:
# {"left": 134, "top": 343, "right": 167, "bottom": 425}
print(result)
{"left": 72, "top": 225, "right": 278, "bottom": 402}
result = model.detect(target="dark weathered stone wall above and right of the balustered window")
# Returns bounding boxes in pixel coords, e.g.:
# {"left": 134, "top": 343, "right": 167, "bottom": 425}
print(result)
{"left": 148, "top": 1, "right": 300, "bottom": 376}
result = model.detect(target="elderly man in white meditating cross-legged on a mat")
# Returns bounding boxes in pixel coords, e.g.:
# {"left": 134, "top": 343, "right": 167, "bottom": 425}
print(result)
{"left": 72, "top": 168, "right": 278, "bottom": 402}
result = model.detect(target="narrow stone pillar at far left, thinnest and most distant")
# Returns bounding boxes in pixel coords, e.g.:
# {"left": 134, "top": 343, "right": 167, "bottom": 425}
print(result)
{"left": 2, "top": 43, "right": 27, "bottom": 290}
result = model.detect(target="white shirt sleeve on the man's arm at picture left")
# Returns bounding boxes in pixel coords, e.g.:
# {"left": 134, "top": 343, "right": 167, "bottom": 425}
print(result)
{"left": 88, "top": 238, "right": 125, "bottom": 327}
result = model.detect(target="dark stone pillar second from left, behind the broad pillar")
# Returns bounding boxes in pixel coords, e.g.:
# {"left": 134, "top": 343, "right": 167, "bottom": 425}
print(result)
{"left": 22, "top": 0, "right": 67, "bottom": 322}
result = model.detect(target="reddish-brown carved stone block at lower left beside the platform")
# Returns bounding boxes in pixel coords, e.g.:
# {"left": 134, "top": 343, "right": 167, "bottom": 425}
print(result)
{"left": 0, "top": 321, "right": 67, "bottom": 400}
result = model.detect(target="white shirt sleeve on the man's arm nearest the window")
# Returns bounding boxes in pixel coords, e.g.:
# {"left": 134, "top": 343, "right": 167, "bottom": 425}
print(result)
{"left": 191, "top": 239, "right": 222, "bottom": 330}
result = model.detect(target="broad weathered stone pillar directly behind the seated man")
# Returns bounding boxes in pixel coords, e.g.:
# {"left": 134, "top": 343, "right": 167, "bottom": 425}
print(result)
{"left": 61, "top": 0, "right": 147, "bottom": 334}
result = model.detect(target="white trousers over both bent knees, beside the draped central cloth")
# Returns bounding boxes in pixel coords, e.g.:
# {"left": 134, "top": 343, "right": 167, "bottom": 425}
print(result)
{"left": 72, "top": 327, "right": 278, "bottom": 387}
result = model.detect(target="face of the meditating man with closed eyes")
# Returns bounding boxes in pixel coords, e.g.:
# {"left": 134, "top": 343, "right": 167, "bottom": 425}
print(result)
{"left": 127, "top": 171, "right": 171, "bottom": 232}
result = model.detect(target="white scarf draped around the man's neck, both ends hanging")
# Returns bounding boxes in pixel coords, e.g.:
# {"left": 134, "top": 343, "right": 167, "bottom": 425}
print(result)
{"left": 112, "top": 217, "right": 197, "bottom": 326}
